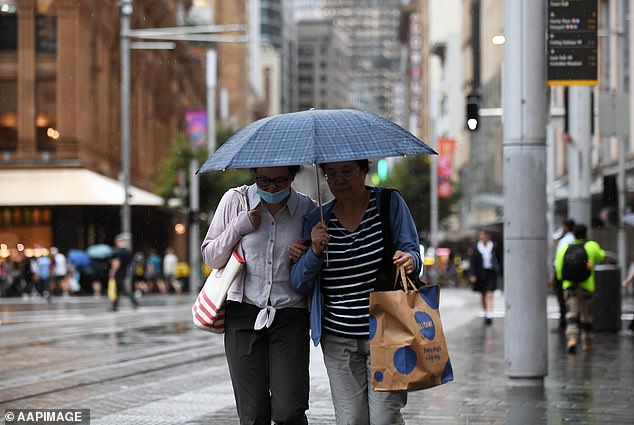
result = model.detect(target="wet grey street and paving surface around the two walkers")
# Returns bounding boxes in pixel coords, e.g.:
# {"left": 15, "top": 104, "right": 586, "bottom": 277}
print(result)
{"left": 0, "top": 288, "right": 634, "bottom": 425}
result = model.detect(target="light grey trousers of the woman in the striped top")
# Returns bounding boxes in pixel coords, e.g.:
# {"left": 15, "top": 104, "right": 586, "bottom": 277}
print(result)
{"left": 321, "top": 334, "right": 407, "bottom": 425}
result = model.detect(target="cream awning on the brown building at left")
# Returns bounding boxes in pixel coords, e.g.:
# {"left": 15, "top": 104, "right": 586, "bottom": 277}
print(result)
{"left": 0, "top": 168, "right": 163, "bottom": 206}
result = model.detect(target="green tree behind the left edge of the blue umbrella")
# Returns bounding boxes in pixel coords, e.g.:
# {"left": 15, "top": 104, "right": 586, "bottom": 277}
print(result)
{"left": 154, "top": 127, "right": 252, "bottom": 212}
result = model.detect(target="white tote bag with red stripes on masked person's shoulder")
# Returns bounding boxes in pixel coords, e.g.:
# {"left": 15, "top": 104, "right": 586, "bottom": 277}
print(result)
{"left": 192, "top": 250, "right": 245, "bottom": 334}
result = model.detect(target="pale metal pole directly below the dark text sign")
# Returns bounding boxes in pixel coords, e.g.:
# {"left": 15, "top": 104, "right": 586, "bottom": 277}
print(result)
{"left": 567, "top": 86, "right": 592, "bottom": 229}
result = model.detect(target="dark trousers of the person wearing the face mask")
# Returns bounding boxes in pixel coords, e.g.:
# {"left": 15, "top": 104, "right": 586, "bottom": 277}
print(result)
{"left": 225, "top": 302, "right": 310, "bottom": 425}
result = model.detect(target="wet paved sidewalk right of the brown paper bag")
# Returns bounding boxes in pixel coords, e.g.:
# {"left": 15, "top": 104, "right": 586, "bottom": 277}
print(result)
{"left": 398, "top": 319, "right": 634, "bottom": 425}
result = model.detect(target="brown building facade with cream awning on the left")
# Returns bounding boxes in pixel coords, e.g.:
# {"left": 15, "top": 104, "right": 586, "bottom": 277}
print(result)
{"left": 0, "top": 0, "right": 205, "bottom": 256}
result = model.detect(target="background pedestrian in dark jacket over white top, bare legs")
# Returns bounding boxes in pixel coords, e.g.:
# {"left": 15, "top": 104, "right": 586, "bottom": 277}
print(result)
{"left": 469, "top": 230, "right": 500, "bottom": 325}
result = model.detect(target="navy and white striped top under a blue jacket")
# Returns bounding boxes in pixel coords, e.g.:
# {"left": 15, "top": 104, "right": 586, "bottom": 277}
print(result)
{"left": 321, "top": 194, "right": 384, "bottom": 339}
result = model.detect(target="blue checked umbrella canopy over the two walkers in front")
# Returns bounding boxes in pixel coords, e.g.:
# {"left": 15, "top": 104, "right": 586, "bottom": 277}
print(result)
{"left": 198, "top": 109, "right": 436, "bottom": 173}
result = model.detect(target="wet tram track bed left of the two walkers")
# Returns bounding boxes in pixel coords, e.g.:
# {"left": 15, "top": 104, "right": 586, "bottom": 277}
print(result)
{"left": 0, "top": 298, "right": 224, "bottom": 408}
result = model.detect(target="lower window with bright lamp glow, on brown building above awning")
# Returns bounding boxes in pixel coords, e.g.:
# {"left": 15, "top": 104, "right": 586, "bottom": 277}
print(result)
{"left": 35, "top": 80, "right": 60, "bottom": 151}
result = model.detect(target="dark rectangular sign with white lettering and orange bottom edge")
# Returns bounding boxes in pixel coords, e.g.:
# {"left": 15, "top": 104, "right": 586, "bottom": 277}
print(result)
{"left": 547, "top": 0, "right": 598, "bottom": 86}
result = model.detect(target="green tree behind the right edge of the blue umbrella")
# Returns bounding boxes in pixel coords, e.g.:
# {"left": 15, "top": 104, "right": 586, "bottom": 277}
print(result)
{"left": 385, "top": 156, "right": 460, "bottom": 237}
